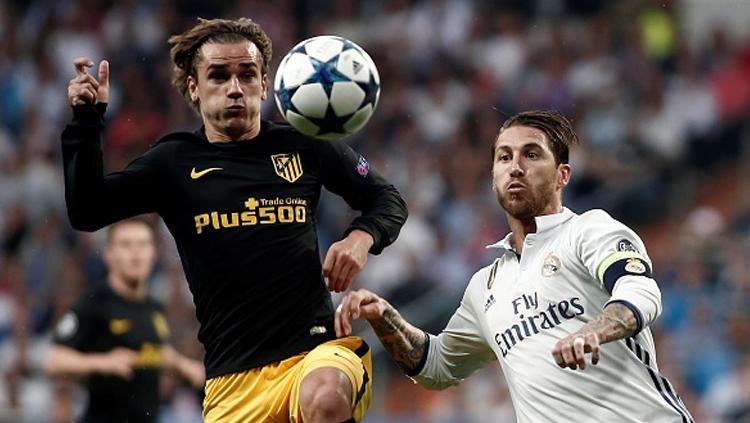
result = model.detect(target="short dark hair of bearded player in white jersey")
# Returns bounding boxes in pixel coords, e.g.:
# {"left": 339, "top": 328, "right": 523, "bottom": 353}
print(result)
{"left": 500, "top": 110, "right": 581, "bottom": 165}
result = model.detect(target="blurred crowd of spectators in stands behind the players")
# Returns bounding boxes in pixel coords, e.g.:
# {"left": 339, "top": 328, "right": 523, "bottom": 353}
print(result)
{"left": 0, "top": 0, "right": 750, "bottom": 423}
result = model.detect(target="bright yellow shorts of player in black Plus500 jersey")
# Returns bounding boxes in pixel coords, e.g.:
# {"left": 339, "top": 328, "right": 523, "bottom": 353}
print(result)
{"left": 203, "top": 336, "right": 372, "bottom": 423}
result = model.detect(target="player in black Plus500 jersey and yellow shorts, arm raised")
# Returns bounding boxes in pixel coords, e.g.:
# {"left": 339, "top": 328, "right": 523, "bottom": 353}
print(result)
{"left": 62, "top": 18, "right": 407, "bottom": 423}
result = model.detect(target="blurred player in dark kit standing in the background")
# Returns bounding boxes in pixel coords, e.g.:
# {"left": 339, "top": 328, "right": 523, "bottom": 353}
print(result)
{"left": 46, "top": 219, "right": 205, "bottom": 423}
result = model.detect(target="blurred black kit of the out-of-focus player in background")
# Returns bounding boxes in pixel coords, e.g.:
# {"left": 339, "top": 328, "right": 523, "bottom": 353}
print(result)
{"left": 54, "top": 285, "right": 169, "bottom": 423}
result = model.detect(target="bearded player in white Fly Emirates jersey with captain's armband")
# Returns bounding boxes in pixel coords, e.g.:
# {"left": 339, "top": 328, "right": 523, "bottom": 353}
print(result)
{"left": 336, "top": 111, "right": 693, "bottom": 423}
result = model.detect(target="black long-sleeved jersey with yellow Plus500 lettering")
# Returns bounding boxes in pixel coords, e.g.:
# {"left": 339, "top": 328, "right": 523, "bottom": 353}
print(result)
{"left": 62, "top": 103, "right": 407, "bottom": 378}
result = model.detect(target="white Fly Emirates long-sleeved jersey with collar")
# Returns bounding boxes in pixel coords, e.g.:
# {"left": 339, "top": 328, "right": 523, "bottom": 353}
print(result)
{"left": 414, "top": 209, "right": 693, "bottom": 423}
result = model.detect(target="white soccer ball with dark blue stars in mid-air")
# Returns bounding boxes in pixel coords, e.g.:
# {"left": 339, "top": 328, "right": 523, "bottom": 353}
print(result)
{"left": 273, "top": 35, "right": 380, "bottom": 140}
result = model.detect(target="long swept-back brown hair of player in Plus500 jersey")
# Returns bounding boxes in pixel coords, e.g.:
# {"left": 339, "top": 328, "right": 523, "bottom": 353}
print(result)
{"left": 168, "top": 18, "right": 273, "bottom": 111}
